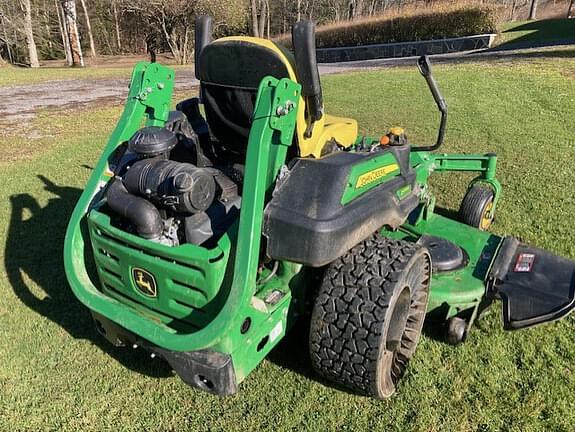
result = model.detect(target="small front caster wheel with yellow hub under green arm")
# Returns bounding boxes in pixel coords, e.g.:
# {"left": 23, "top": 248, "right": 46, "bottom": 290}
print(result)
{"left": 459, "top": 185, "right": 495, "bottom": 231}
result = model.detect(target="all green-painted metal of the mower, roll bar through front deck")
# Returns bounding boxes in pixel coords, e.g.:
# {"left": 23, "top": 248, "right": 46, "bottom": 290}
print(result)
{"left": 64, "top": 63, "right": 501, "bottom": 382}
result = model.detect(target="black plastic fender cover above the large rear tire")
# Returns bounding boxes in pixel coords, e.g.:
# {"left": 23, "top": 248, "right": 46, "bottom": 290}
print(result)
{"left": 263, "top": 152, "right": 419, "bottom": 267}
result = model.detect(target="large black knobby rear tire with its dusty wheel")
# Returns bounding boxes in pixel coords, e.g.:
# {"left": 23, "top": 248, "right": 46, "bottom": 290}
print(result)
{"left": 309, "top": 234, "right": 431, "bottom": 399}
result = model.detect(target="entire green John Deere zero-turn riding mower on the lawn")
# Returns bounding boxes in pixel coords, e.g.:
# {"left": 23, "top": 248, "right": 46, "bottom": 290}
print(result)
{"left": 64, "top": 17, "right": 575, "bottom": 398}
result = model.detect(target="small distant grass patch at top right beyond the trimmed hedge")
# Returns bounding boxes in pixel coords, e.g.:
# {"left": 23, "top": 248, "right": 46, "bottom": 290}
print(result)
{"left": 496, "top": 19, "right": 575, "bottom": 46}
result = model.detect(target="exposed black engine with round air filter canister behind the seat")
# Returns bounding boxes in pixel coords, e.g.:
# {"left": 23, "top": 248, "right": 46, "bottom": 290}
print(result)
{"left": 106, "top": 111, "right": 243, "bottom": 246}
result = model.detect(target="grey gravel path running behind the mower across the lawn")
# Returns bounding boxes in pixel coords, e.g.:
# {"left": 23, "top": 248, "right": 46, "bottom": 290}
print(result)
{"left": 0, "top": 45, "right": 575, "bottom": 138}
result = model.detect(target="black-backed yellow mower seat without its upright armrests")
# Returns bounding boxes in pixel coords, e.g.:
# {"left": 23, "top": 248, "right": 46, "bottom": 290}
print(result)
{"left": 200, "top": 36, "right": 358, "bottom": 158}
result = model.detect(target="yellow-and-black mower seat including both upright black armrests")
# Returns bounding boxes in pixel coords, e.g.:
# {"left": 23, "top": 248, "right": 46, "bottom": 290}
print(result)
{"left": 195, "top": 16, "right": 357, "bottom": 158}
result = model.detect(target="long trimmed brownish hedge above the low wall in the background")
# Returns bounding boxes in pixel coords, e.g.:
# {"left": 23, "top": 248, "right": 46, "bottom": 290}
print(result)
{"left": 277, "top": 6, "right": 496, "bottom": 48}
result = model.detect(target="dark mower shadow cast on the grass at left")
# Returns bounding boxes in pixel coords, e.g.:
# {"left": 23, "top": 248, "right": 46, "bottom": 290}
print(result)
{"left": 4, "top": 176, "right": 172, "bottom": 377}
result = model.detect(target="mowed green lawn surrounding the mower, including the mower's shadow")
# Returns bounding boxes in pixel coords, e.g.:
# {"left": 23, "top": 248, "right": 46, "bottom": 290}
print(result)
{"left": 0, "top": 59, "right": 575, "bottom": 432}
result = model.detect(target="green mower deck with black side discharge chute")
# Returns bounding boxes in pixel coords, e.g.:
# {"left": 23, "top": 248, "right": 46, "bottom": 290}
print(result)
{"left": 383, "top": 214, "right": 575, "bottom": 330}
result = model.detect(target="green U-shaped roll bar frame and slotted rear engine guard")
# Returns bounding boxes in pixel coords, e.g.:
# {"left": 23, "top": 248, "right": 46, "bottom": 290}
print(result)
{"left": 64, "top": 69, "right": 308, "bottom": 381}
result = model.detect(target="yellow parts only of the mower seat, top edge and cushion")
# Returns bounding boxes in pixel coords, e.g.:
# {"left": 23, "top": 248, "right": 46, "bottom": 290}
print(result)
{"left": 209, "top": 36, "right": 358, "bottom": 158}
